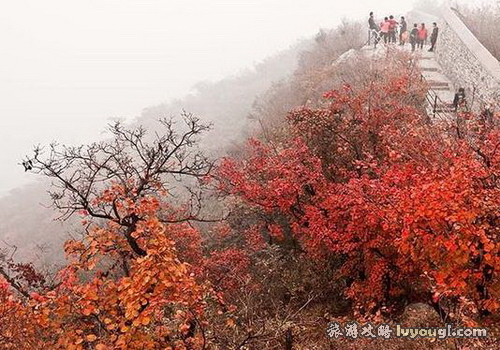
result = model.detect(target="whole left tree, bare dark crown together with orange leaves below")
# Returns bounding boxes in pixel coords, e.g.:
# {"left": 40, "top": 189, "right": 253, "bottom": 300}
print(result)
{"left": 2, "top": 114, "right": 223, "bottom": 349}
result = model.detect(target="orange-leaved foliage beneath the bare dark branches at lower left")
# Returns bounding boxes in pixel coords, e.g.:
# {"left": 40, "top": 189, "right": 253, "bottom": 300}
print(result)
{"left": 0, "top": 186, "right": 206, "bottom": 349}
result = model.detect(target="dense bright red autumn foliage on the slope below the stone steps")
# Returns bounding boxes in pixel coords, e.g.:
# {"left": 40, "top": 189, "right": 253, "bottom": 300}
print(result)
{"left": 220, "top": 61, "right": 500, "bottom": 324}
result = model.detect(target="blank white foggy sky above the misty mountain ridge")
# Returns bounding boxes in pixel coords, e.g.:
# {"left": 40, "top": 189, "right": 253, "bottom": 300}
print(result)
{"left": 0, "top": 0, "right": 454, "bottom": 195}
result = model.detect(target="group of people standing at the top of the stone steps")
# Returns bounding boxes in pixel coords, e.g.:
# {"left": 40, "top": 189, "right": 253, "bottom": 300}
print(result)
{"left": 368, "top": 12, "right": 439, "bottom": 52}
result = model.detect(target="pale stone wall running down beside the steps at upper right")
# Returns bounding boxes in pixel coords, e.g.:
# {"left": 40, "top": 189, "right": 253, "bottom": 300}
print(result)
{"left": 436, "top": 7, "right": 500, "bottom": 111}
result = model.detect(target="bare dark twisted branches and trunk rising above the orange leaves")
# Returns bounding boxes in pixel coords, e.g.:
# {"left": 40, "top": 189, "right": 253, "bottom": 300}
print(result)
{"left": 24, "top": 113, "right": 218, "bottom": 255}
